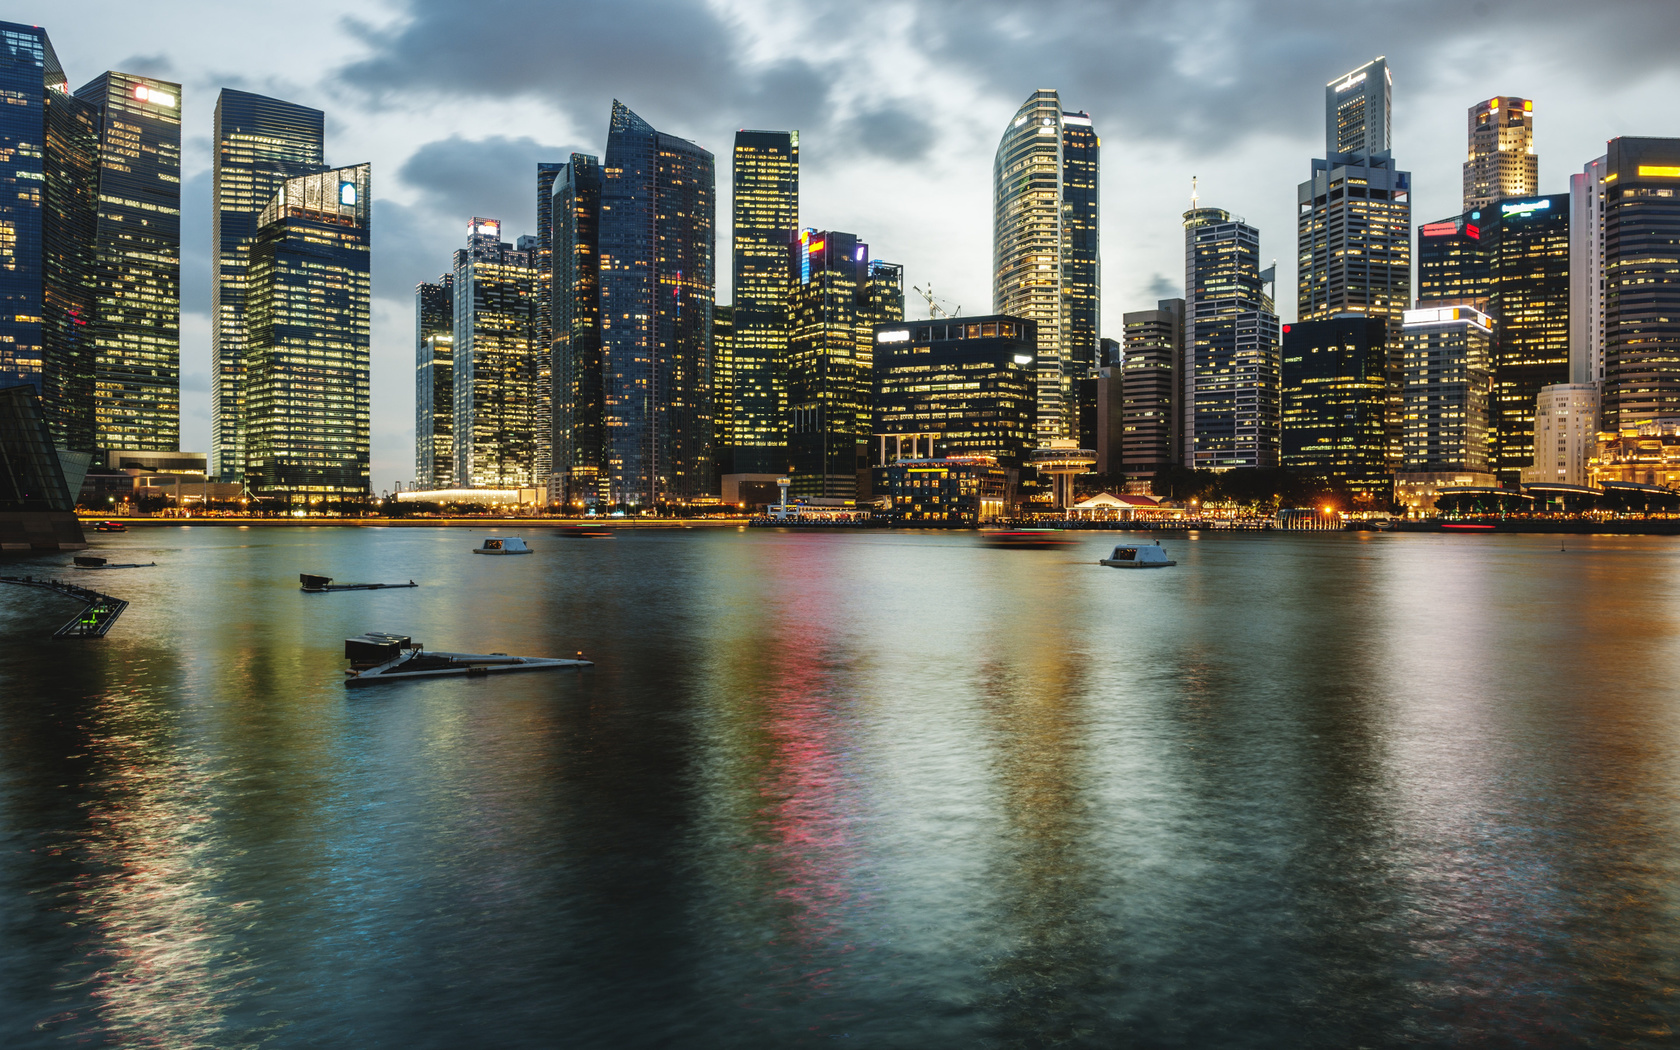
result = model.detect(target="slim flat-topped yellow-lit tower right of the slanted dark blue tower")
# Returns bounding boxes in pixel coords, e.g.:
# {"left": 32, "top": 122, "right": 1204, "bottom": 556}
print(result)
{"left": 717, "top": 131, "right": 800, "bottom": 474}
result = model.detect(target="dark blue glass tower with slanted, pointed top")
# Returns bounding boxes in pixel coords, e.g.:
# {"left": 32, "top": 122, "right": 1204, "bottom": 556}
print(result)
{"left": 600, "top": 101, "right": 717, "bottom": 506}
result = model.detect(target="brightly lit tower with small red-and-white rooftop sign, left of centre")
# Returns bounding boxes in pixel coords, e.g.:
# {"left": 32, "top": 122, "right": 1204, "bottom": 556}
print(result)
{"left": 450, "top": 218, "right": 549, "bottom": 489}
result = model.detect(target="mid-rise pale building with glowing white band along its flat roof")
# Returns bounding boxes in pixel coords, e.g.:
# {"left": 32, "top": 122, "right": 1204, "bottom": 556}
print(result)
{"left": 1401, "top": 306, "right": 1494, "bottom": 470}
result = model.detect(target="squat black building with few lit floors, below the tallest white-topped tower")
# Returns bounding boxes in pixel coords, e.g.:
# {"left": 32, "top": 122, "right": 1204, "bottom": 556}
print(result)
{"left": 1284, "top": 314, "right": 1389, "bottom": 501}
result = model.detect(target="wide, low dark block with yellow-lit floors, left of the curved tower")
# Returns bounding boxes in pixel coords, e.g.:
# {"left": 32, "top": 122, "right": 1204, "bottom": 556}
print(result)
{"left": 874, "top": 314, "right": 1038, "bottom": 469}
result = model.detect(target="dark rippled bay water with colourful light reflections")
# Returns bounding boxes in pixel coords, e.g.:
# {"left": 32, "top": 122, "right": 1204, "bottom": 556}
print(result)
{"left": 0, "top": 528, "right": 1680, "bottom": 1048}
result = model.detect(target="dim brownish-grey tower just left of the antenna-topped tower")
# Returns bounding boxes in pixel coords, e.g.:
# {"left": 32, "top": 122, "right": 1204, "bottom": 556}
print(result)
{"left": 1122, "top": 299, "right": 1184, "bottom": 479}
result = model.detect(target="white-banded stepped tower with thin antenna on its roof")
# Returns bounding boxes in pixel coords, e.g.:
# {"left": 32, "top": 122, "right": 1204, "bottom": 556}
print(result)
{"left": 1183, "top": 208, "right": 1280, "bottom": 470}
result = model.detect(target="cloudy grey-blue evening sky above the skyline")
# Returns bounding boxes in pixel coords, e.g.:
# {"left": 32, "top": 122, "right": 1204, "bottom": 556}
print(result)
{"left": 39, "top": 0, "right": 1680, "bottom": 489}
